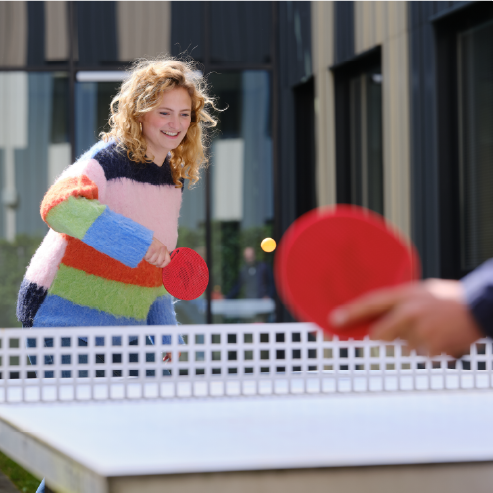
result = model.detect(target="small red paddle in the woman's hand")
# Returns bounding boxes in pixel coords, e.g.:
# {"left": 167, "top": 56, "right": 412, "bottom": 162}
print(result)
{"left": 163, "top": 247, "right": 209, "bottom": 300}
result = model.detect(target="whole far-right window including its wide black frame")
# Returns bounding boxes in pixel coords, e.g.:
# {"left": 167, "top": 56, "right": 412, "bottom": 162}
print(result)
{"left": 434, "top": 2, "right": 493, "bottom": 279}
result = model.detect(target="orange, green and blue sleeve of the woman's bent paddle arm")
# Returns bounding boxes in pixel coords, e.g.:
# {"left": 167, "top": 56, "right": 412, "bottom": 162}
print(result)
{"left": 41, "top": 174, "right": 153, "bottom": 267}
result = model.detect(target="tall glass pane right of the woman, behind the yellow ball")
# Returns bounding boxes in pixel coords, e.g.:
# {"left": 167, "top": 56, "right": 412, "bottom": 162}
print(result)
{"left": 209, "top": 71, "right": 275, "bottom": 323}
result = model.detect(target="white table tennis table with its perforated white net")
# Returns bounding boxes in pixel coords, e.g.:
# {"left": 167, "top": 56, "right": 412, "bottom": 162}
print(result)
{"left": 0, "top": 324, "right": 493, "bottom": 493}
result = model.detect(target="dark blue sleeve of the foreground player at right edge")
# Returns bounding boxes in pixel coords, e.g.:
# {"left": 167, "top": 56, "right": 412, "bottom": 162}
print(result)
{"left": 461, "top": 259, "right": 493, "bottom": 337}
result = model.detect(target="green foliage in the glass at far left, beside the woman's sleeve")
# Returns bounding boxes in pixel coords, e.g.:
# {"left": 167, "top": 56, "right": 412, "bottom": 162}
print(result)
{"left": 0, "top": 235, "right": 42, "bottom": 327}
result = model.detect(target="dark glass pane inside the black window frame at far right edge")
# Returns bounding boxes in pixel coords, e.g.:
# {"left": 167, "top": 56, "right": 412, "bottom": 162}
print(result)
{"left": 458, "top": 21, "right": 493, "bottom": 271}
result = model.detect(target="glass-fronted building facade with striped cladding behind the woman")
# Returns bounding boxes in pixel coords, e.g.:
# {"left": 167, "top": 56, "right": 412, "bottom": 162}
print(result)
{"left": 0, "top": 0, "right": 315, "bottom": 325}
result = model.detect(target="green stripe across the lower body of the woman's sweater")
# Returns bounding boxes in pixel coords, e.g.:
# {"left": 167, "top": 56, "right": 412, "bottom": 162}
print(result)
{"left": 48, "top": 264, "right": 166, "bottom": 320}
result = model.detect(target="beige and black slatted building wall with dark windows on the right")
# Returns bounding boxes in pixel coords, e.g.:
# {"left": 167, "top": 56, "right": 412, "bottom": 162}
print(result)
{"left": 312, "top": 0, "right": 493, "bottom": 279}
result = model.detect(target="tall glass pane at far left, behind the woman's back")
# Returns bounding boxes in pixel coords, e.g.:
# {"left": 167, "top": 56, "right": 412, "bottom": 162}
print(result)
{"left": 0, "top": 71, "right": 71, "bottom": 327}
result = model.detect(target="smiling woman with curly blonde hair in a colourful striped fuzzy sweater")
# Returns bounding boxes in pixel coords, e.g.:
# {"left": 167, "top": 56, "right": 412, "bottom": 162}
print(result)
{"left": 17, "top": 59, "right": 216, "bottom": 327}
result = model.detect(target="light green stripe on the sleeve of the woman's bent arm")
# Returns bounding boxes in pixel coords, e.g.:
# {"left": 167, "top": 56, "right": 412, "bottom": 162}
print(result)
{"left": 46, "top": 195, "right": 106, "bottom": 240}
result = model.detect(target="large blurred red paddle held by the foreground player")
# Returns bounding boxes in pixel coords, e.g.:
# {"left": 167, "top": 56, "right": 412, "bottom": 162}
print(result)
{"left": 274, "top": 205, "right": 420, "bottom": 340}
